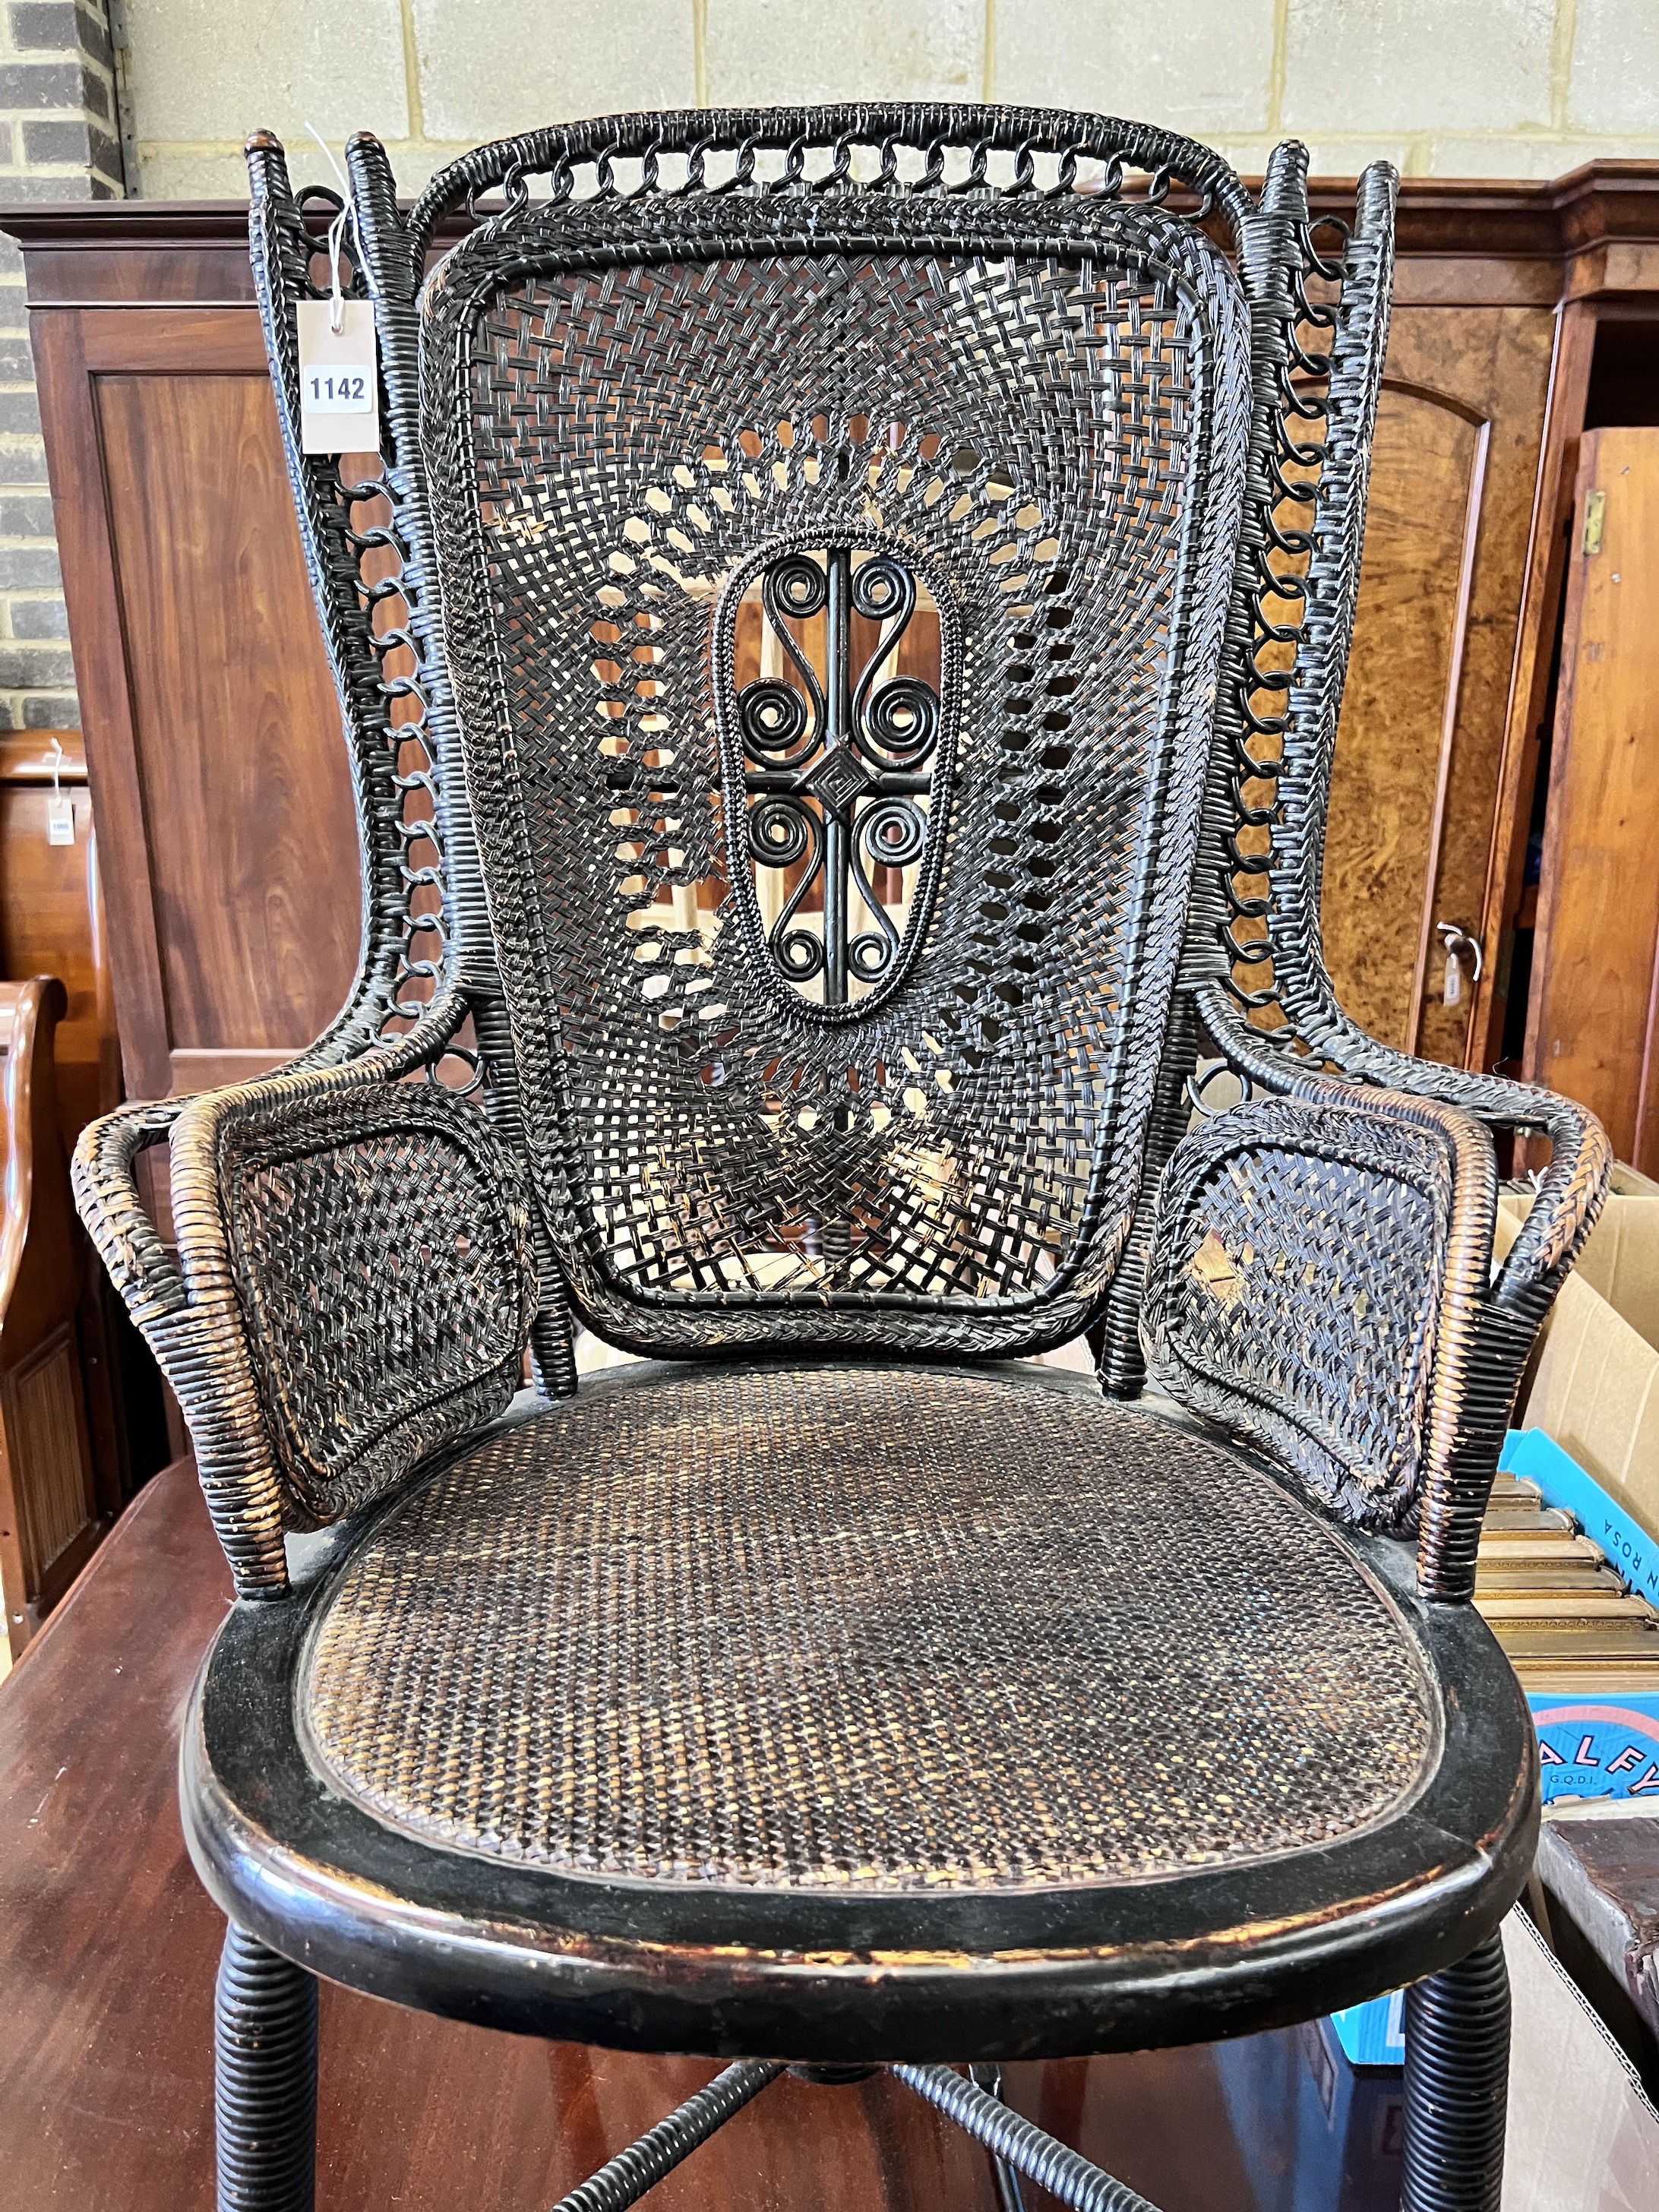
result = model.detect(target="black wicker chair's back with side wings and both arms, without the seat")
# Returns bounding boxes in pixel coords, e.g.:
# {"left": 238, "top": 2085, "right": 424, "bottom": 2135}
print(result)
{"left": 77, "top": 106, "right": 1604, "bottom": 1595}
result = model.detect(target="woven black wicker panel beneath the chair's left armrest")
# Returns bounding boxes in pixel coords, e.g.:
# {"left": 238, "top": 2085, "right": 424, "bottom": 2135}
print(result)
{"left": 221, "top": 1084, "right": 536, "bottom": 1528}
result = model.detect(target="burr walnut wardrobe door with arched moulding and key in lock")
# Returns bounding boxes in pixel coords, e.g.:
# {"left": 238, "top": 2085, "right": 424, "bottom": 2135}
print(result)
{"left": 1322, "top": 308, "right": 1555, "bottom": 1066}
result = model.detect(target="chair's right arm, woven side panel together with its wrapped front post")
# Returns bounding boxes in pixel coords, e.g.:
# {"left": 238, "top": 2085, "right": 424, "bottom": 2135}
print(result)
{"left": 1142, "top": 1075, "right": 1606, "bottom": 1597}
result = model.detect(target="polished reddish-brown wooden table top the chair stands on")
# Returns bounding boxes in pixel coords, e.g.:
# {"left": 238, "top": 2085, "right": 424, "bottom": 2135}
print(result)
{"left": 0, "top": 1462, "right": 1398, "bottom": 2212}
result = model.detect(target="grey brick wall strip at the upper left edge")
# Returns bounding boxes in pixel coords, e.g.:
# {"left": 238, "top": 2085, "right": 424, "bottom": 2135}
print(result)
{"left": 0, "top": 0, "right": 124, "bottom": 730}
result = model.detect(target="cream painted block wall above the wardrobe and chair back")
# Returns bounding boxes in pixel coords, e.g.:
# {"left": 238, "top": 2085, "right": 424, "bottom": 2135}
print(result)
{"left": 126, "top": 0, "right": 1659, "bottom": 197}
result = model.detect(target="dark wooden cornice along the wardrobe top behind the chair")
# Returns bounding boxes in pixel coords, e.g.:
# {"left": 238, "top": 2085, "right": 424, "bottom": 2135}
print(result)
{"left": 0, "top": 162, "right": 1659, "bottom": 308}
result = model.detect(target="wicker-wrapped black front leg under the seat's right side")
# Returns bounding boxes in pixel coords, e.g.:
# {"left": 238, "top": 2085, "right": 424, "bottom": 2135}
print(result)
{"left": 1400, "top": 1936, "right": 1509, "bottom": 2212}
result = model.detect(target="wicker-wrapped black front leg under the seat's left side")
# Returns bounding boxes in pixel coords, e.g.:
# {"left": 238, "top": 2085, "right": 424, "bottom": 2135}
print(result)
{"left": 213, "top": 1920, "right": 316, "bottom": 2212}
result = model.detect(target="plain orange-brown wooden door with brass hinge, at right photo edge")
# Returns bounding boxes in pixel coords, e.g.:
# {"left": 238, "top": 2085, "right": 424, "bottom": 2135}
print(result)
{"left": 1526, "top": 429, "right": 1659, "bottom": 1174}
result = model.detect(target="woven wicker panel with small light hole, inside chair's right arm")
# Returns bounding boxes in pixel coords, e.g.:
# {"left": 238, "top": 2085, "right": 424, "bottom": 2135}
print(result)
{"left": 1142, "top": 1101, "right": 1453, "bottom": 1528}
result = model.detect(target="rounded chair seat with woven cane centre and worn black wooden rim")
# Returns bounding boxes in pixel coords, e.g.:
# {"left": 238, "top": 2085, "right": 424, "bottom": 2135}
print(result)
{"left": 188, "top": 1365, "right": 1531, "bottom": 2057}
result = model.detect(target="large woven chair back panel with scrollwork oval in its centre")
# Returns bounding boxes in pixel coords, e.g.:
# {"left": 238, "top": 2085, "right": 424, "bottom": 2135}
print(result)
{"left": 434, "top": 208, "right": 1247, "bottom": 1351}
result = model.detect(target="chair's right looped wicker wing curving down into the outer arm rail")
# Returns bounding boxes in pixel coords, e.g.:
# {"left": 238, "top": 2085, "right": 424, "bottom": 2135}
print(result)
{"left": 1188, "top": 148, "right": 1610, "bottom": 1345}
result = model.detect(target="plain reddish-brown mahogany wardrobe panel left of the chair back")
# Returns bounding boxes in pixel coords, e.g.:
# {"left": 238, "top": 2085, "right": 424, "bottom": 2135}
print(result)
{"left": 97, "top": 374, "right": 361, "bottom": 1070}
